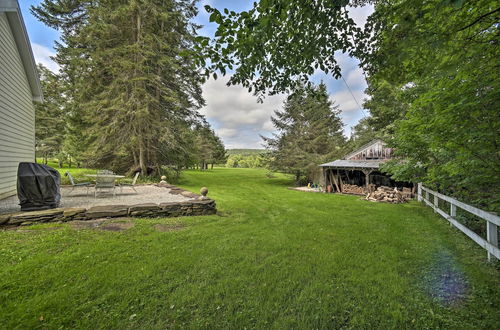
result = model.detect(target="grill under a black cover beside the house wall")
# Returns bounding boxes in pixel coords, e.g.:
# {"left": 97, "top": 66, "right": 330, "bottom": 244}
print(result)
{"left": 17, "top": 163, "right": 61, "bottom": 211}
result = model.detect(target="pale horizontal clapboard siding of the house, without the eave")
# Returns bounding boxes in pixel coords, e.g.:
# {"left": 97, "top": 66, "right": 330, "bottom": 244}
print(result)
{"left": 0, "top": 13, "right": 35, "bottom": 199}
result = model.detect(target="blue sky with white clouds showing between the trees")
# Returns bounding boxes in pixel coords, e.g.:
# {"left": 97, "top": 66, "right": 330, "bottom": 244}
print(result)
{"left": 19, "top": 0, "right": 373, "bottom": 149}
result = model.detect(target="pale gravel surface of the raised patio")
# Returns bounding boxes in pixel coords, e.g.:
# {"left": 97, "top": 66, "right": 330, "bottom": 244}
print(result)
{"left": 0, "top": 185, "right": 191, "bottom": 214}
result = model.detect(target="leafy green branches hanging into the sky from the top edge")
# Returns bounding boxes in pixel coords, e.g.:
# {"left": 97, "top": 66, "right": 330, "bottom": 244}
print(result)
{"left": 199, "top": 0, "right": 369, "bottom": 96}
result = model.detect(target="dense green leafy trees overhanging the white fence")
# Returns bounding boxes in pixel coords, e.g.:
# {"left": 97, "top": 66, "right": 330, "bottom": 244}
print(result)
{"left": 363, "top": 0, "right": 500, "bottom": 210}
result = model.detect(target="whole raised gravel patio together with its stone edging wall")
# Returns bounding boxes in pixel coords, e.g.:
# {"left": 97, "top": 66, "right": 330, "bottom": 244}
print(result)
{"left": 0, "top": 184, "right": 217, "bottom": 226}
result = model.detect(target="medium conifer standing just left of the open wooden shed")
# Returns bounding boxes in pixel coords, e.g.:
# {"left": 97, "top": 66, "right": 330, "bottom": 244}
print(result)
{"left": 263, "top": 83, "right": 345, "bottom": 181}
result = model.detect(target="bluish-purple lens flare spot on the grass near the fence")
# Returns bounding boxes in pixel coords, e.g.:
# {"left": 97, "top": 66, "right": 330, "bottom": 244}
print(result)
{"left": 424, "top": 250, "right": 469, "bottom": 306}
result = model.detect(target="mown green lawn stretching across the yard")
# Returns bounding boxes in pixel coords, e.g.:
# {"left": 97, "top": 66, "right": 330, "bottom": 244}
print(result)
{"left": 0, "top": 168, "right": 500, "bottom": 329}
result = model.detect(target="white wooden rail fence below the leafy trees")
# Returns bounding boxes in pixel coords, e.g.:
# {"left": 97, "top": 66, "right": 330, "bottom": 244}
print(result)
{"left": 418, "top": 183, "right": 500, "bottom": 261}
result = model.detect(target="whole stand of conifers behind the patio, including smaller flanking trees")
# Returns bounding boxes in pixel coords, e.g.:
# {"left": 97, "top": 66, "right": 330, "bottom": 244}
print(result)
{"left": 31, "top": 0, "right": 225, "bottom": 173}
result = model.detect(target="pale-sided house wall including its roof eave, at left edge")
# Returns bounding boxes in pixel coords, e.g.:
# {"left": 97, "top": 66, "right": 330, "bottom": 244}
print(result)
{"left": 0, "top": 0, "right": 42, "bottom": 199}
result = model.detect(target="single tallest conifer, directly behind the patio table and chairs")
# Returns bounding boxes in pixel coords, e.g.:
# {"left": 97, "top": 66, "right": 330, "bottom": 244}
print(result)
{"left": 33, "top": 0, "right": 204, "bottom": 173}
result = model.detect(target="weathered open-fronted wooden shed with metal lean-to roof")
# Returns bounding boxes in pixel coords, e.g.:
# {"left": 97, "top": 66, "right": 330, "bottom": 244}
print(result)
{"left": 320, "top": 139, "right": 413, "bottom": 194}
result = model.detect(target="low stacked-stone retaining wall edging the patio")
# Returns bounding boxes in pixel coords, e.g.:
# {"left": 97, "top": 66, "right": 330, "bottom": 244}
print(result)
{"left": 0, "top": 199, "right": 217, "bottom": 226}
